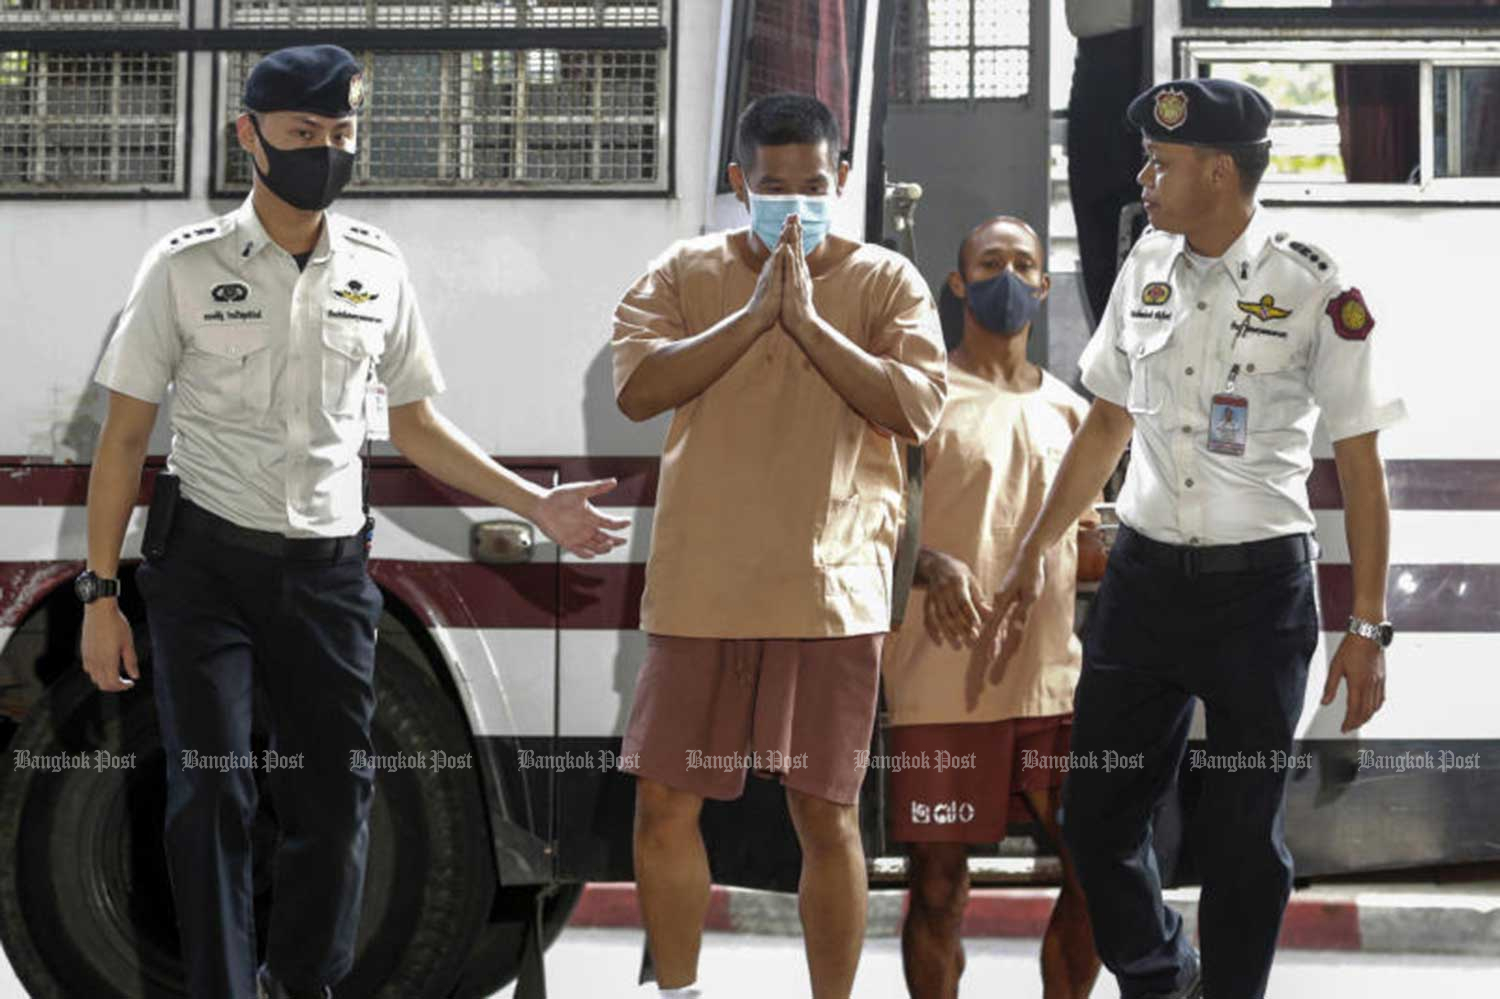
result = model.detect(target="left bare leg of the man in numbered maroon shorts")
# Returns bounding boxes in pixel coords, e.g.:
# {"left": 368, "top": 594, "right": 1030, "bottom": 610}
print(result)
{"left": 902, "top": 843, "right": 969, "bottom": 999}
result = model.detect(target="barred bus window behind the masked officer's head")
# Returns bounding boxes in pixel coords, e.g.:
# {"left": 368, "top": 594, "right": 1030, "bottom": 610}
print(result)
{"left": 219, "top": 0, "right": 669, "bottom": 194}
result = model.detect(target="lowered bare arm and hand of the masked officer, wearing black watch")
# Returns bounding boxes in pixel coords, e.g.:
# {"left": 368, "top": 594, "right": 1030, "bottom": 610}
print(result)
{"left": 81, "top": 392, "right": 156, "bottom": 692}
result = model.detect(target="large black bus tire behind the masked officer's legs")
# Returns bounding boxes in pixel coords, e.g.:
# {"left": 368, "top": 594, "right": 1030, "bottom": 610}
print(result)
{"left": 0, "top": 620, "right": 495, "bottom": 999}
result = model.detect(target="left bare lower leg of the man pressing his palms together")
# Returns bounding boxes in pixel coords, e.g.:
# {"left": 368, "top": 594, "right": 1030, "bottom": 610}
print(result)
{"left": 635, "top": 777, "right": 708, "bottom": 989}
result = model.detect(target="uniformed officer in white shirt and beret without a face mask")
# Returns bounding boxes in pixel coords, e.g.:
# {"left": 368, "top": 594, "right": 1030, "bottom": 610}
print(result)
{"left": 992, "top": 80, "right": 1406, "bottom": 999}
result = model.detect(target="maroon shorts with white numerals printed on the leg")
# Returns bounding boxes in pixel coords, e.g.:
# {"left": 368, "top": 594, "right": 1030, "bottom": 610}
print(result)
{"left": 882, "top": 714, "right": 1073, "bottom": 843}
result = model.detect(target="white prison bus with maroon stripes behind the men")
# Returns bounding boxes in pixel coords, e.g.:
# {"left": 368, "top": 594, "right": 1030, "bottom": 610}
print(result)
{"left": 0, "top": 0, "right": 1500, "bottom": 999}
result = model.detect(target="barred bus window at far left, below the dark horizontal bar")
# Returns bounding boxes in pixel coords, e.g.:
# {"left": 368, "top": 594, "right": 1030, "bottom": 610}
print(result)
{"left": 0, "top": 51, "right": 183, "bottom": 194}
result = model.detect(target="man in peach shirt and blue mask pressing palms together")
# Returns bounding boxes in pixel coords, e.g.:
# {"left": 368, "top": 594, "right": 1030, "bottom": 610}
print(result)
{"left": 614, "top": 95, "right": 945, "bottom": 999}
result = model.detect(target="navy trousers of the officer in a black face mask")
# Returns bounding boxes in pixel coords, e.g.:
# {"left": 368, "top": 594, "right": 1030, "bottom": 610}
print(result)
{"left": 137, "top": 510, "right": 381, "bottom": 999}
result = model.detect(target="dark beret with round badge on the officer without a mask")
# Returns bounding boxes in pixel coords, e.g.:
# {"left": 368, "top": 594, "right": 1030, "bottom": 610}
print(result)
{"left": 1125, "top": 80, "right": 1272, "bottom": 146}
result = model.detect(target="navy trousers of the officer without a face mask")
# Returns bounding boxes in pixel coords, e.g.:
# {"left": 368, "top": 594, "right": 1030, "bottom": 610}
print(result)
{"left": 1064, "top": 528, "right": 1319, "bottom": 999}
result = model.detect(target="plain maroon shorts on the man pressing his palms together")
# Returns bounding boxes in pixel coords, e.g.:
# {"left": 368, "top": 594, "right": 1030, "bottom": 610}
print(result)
{"left": 620, "top": 635, "right": 885, "bottom": 804}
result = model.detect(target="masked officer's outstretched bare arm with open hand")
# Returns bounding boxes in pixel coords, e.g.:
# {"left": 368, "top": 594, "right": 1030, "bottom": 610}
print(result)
{"left": 390, "top": 399, "right": 630, "bottom": 558}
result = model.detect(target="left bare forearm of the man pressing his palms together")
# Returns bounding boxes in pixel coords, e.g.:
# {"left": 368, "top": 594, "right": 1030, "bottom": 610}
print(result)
{"left": 618, "top": 246, "right": 786, "bottom": 422}
